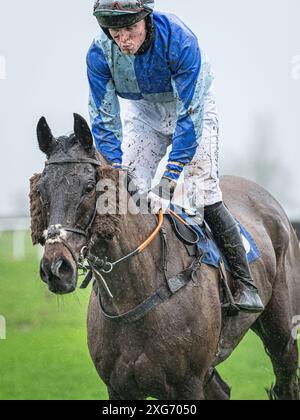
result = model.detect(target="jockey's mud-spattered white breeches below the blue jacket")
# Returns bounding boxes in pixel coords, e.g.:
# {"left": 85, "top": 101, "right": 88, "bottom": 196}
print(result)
{"left": 122, "top": 83, "right": 222, "bottom": 209}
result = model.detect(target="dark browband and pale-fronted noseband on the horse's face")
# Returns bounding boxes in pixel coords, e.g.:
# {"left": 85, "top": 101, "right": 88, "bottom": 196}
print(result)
{"left": 43, "top": 158, "right": 101, "bottom": 266}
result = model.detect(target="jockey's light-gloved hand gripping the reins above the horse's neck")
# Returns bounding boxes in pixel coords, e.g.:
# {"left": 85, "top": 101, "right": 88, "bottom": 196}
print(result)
{"left": 148, "top": 178, "right": 177, "bottom": 214}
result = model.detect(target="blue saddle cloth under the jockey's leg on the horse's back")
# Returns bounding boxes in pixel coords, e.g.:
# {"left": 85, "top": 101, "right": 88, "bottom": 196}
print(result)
{"left": 170, "top": 205, "right": 261, "bottom": 272}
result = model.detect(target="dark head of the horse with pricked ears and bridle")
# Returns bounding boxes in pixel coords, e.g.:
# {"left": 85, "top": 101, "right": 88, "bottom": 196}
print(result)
{"left": 31, "top": 114, "right": 99, "bottom": 294}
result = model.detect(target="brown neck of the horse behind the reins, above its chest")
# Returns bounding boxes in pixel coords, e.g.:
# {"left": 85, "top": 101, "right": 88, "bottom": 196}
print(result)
{"left": 94, "top": 214, "right": 162, "bottom": 314}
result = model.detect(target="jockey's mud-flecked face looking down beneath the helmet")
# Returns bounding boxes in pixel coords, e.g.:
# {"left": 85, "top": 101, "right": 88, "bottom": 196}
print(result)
{"left": 109, "top": 20, "right": 147, "bottom": 55}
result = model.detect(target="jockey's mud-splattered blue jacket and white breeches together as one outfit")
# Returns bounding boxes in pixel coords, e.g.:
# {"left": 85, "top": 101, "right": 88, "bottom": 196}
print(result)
{"left": 87, "top": 12, "right": 222, "bottom": 207}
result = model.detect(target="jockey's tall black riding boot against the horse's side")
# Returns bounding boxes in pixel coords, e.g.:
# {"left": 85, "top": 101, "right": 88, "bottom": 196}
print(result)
{"left": 204, "top": 202, "right": 264, "bottom": 313}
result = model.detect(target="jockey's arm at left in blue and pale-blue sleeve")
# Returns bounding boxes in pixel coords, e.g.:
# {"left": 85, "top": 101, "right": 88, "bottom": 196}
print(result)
{"left": 87, "top": 42, "right": 122, "bottom": 165}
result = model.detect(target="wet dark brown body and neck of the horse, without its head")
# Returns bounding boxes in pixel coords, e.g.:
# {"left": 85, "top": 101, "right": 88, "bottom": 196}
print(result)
{"left": 88, "top": 177, "right": 300, "bottom": 399}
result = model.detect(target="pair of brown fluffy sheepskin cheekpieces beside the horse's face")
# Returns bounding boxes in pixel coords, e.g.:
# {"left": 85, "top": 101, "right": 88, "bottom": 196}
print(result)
{"left": 29, "top": 165, "right": 121, "bottom": 245}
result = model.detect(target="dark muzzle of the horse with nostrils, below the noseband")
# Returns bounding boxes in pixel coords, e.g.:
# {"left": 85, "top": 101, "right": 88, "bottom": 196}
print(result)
{"left": 40, "top": 256, "right": 77, "bottom": 295}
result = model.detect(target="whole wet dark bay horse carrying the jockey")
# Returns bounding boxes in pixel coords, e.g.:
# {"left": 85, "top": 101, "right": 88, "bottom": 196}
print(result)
{"left": 31, "top": 115, "right": 300, "bottom": 400}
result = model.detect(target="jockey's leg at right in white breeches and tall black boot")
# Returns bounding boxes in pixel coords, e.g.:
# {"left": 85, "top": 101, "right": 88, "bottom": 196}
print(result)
{"left": 185, "top": 85, "right": 264, "bottom": 313}
